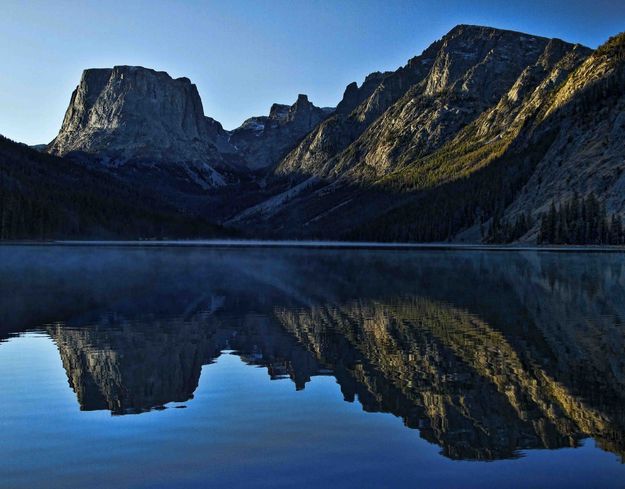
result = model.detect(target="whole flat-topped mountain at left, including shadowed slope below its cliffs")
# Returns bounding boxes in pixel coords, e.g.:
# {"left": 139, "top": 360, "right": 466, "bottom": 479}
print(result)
{"left": 48, "top": 66, "right": 246, "bottom": 210}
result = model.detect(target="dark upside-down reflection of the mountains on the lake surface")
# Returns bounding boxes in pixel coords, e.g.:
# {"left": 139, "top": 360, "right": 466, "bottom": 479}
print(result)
{"left": 0, "top": 247, "right": 625, "bottom": 460}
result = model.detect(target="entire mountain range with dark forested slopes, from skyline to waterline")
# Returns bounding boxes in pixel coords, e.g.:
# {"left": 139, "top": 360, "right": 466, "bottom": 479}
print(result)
{"left": 0, "top": 25, "right": 625, "bottom": 244}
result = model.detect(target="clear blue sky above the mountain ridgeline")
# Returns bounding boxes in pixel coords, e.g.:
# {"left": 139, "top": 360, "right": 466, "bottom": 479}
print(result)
{"left": 0, "top": 0, "right": 625, "bottom": 144}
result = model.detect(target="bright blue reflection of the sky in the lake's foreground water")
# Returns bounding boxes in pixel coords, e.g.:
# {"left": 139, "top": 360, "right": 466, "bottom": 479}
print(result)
{"left": 0, "top": 333, "right": 624, "bottom": 488}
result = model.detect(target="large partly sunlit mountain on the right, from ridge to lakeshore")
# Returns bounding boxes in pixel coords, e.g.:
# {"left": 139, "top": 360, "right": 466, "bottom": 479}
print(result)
{"left": 230, "top": 26, "right": 625, "bottom": 244}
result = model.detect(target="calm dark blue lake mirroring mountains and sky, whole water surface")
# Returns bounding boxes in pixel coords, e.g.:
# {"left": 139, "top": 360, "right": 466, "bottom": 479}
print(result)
{"left": 0, "top": 246, "right": 625, "bottom": 489}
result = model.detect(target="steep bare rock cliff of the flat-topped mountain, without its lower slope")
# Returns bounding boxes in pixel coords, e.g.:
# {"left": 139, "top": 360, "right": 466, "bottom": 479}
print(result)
{"left": 48, "top": 66, "right": 233, "bottom": 189}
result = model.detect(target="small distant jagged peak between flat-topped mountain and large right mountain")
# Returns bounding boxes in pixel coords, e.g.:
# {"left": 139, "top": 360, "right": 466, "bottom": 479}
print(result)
{"left": 230, "top": 94, "right": 334, "bottom": 170}
